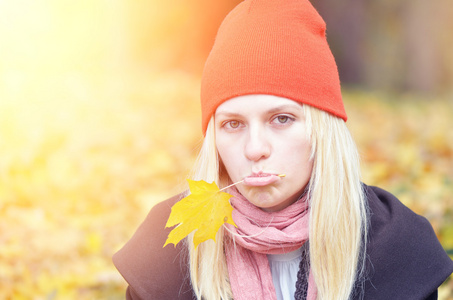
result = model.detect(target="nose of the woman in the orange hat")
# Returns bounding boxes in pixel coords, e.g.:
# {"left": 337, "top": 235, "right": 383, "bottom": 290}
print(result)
{"left": 244, "top": 126, "right": 271, "bottom": 161}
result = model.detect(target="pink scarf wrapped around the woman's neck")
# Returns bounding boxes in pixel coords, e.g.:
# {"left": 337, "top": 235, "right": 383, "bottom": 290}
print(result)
{"left": 226, "top": 189, "right": 317, "bottom": 300}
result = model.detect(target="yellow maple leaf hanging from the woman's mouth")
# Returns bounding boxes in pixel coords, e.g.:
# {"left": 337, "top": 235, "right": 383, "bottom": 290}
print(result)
{"left": 164, "top": 179, "right": 236, "bottom": 248}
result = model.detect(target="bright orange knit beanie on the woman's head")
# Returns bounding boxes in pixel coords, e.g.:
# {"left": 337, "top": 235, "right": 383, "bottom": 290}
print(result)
{"left": 201, "top": 0, "right": 347, "bottom": 133}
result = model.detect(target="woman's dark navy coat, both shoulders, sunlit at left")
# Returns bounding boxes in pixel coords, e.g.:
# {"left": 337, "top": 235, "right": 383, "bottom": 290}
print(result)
{"left": 113, "top": 185, "right": 453, "bottom": 300}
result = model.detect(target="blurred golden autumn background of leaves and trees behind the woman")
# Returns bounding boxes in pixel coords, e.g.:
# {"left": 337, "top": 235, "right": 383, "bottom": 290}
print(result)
{"left": 0, "top": 0, "right": 453, "bottom": 299}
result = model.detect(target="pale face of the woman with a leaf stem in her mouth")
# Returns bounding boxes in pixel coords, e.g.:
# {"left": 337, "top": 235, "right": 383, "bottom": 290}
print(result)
{"left": 215, "top": 95, "right": 313, "bottom": 211}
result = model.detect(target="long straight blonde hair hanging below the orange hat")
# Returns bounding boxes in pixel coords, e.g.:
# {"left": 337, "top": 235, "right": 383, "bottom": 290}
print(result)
{"left": 188, "top": 105, "right": 368, "bottom": 300}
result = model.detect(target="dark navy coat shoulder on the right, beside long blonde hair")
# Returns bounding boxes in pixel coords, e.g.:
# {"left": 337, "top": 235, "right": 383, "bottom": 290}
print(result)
{"left": 364, "top": 186, "right": 453, "bottom": 299}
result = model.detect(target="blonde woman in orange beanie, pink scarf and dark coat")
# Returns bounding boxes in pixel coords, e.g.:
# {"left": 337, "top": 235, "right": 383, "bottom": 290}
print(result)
{"left": 114, "top": 0, "right": 453, "bottom": 300}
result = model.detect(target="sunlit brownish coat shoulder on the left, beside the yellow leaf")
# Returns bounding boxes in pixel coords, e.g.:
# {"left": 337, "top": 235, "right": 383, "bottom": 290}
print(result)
{"left": 113, "top": 194, "right": 193, "bottom": 299}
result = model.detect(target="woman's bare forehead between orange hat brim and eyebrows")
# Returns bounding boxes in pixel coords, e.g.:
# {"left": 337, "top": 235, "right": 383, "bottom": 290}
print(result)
{"left": 215, "top": 95, "right": 302, "bottom": 115}
